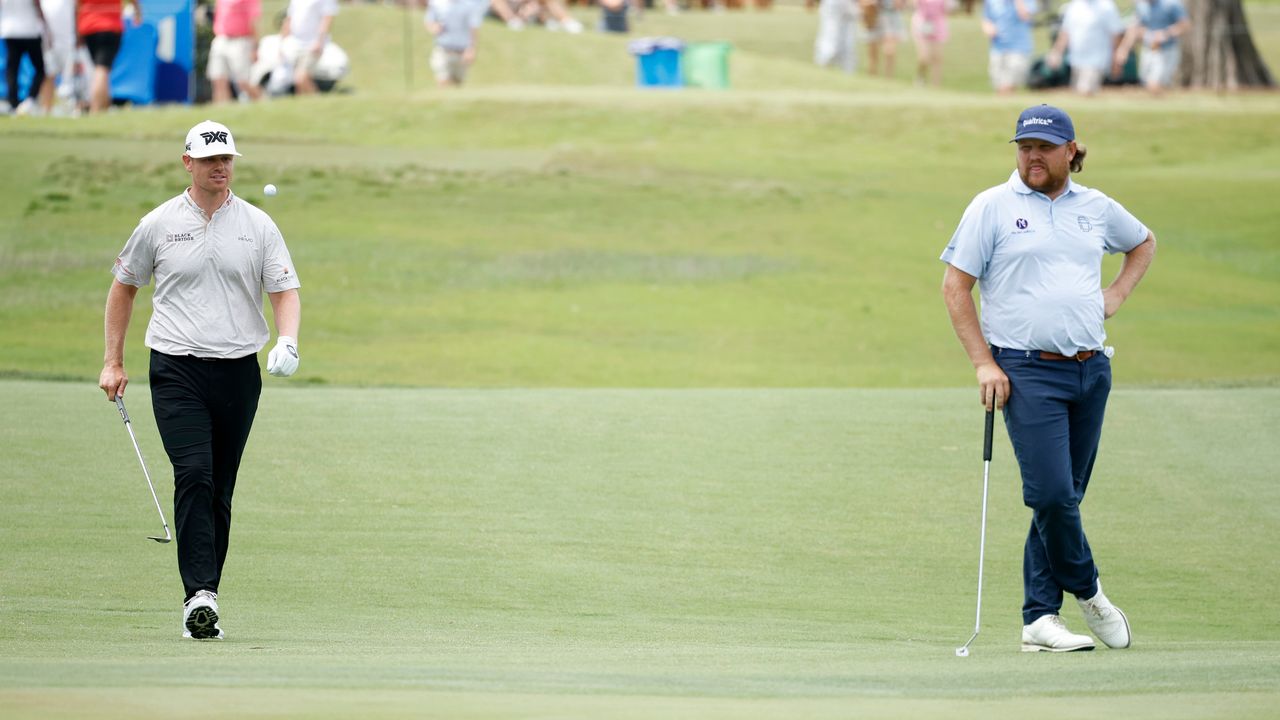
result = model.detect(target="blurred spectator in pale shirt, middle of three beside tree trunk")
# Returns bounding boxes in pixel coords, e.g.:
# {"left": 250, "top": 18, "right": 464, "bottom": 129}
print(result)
{"left": 1047, "top": 0, "right": 1125, "bottom": 95}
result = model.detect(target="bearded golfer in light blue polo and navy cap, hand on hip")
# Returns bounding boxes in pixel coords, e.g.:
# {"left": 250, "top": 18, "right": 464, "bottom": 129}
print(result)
{"left": 941, "top": 105, "right": 1156, "bottom": 652}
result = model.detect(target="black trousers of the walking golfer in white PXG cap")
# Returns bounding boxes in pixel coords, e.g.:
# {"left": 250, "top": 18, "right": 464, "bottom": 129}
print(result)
{"left": 151, "top": 350, "right": 262, "bottom": 600}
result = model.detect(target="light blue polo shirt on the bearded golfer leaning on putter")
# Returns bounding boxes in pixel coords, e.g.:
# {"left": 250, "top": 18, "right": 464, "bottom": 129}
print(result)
{"left": 941, "top": 170, "right": 1148, "bottom": 355}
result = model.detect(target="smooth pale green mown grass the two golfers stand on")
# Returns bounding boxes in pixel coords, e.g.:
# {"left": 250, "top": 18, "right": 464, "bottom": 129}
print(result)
{"left": 0, "top": 380, "right": 1280, "bottom": 719}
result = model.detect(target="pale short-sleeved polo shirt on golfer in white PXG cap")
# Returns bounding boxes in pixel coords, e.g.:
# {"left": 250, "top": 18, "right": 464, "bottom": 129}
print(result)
{"left": 113, "top": 191, "right": 301, "bottom": 359}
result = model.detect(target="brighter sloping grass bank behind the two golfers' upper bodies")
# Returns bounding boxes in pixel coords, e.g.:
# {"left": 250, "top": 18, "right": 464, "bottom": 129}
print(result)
{"left": 0, "top": 5, "right": 1280, "bottom": 388}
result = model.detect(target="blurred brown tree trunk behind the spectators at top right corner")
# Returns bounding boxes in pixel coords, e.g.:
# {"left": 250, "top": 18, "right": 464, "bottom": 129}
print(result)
{"left": 1181, "top": 0, "right": 1275, "bottom": 90}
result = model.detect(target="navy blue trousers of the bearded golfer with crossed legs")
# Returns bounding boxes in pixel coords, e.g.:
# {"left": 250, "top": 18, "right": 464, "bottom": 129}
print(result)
{"left": 992, "top": 347, "right": 1111, "bottom": 625}
